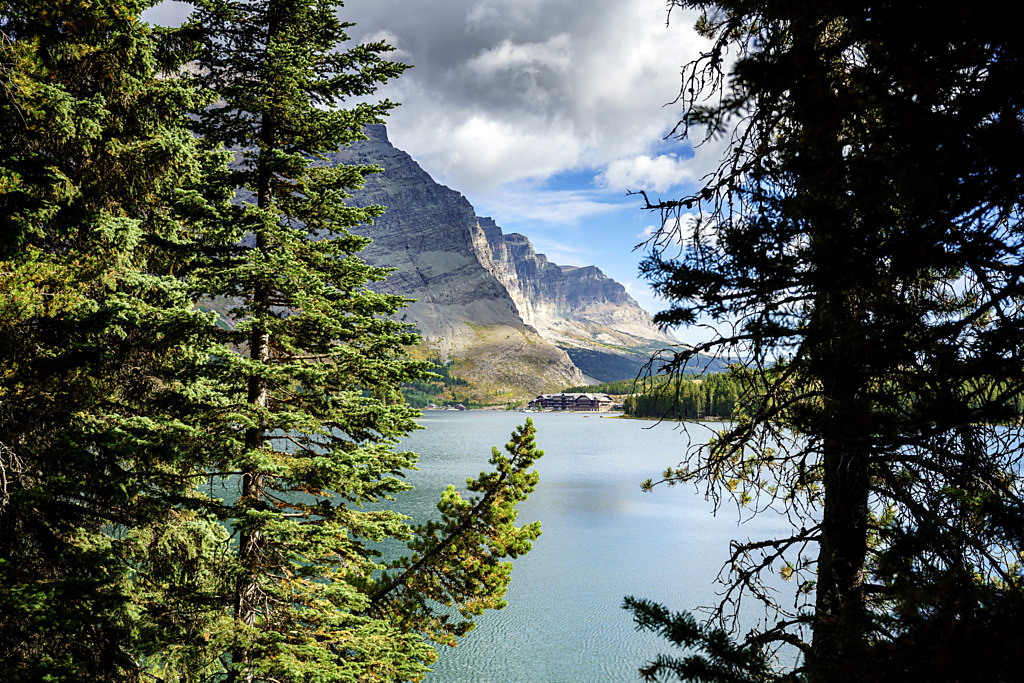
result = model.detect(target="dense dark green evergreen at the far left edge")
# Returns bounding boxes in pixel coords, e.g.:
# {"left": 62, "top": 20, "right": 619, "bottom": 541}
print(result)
{"left": 0, "top": 0, "right": 223, "bottom": 681}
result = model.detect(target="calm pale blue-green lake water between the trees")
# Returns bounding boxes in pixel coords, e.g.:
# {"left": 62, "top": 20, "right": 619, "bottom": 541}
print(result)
{"left": 397, "top": 412, "right": 785, "bottom": 683}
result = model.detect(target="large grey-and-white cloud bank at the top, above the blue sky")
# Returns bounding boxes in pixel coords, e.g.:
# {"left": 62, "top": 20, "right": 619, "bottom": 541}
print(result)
{"left": 345, "top": 0, "right": 703, "bottom": 196}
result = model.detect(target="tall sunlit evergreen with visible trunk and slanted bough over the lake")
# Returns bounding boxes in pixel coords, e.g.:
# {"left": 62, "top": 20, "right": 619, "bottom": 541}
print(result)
{"left": 179, "top": 0, "right": 540, "bottom": 681}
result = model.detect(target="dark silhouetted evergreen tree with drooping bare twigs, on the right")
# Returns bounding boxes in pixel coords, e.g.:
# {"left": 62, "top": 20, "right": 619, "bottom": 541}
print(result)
{"left": 626, "top": 0, "right": 1024, "bottom": 681}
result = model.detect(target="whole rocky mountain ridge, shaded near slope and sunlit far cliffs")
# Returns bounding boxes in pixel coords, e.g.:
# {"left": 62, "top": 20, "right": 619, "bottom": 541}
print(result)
{"left": 328, "top": 126, "right": 678, "bottom": 398}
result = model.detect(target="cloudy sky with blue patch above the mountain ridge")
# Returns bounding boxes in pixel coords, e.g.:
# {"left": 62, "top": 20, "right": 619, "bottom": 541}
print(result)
{"left": 146, "top": 0, "right": 718, "bottom": 339}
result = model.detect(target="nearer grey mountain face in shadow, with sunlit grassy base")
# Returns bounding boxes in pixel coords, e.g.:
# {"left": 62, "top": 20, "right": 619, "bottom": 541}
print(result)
{"left": 329, "top": 126, "right": 583, "bottom": 397}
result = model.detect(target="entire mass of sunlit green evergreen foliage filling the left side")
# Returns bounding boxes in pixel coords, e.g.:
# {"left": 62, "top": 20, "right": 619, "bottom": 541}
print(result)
{"left": 0, "top": 1, "right": 540, "bottom": 681}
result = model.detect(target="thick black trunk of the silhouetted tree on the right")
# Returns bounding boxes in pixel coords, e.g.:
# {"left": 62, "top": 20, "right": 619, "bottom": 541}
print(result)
{"left": 793, "top": 23, "right": 873, "bottom": 671}
